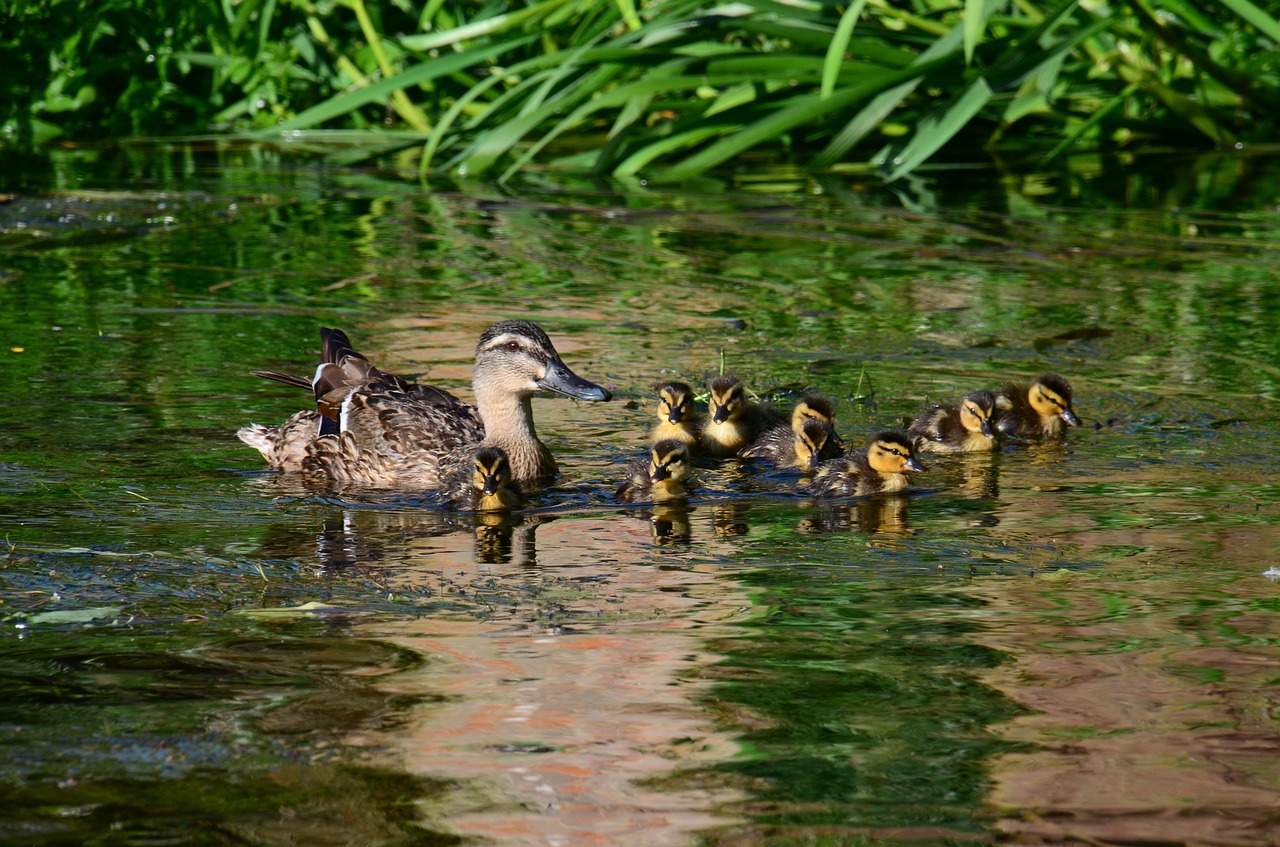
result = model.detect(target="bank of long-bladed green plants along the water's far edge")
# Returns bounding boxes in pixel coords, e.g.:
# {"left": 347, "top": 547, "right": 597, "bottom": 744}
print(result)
{"left": 0, "top": 0, "right": 1280, "bottom": 182}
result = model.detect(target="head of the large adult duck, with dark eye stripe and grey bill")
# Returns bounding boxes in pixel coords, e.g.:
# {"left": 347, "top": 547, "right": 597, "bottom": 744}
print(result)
{"left": 472, "top": 321, "right": 613, "bottom": 400}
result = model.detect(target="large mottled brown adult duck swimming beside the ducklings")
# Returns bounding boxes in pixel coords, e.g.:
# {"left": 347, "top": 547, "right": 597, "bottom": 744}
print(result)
{"left": 238, "top": 321, "right": 613, "bottom": 491}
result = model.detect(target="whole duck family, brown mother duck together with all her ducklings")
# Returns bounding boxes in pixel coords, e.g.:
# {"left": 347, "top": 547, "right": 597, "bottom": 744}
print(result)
{"left": 237, "top": 320, "right": 1080, "bottom": 512}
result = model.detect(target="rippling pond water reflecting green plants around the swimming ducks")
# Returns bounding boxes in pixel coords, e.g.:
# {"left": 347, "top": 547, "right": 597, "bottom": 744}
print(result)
{"left": 0, "top": 148, "right": 1280, "bottom": 844}
